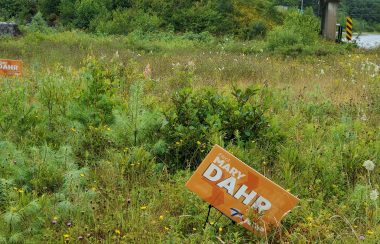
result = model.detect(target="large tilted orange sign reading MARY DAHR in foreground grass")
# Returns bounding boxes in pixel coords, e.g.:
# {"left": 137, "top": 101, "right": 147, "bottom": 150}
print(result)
{"left": 186, "top": 145, "right": 299, "bottom": 234}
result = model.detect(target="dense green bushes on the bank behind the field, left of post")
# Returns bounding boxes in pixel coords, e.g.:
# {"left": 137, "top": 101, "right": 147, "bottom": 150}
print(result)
{"left": 0, "top": 0, "right": 283, "bottom": 39}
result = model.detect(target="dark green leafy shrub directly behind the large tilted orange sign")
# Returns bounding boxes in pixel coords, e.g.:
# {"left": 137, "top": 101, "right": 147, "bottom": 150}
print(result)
{"left": 157, "top": 88, "right": 268, "bottom": 169}
